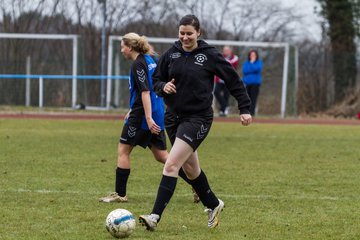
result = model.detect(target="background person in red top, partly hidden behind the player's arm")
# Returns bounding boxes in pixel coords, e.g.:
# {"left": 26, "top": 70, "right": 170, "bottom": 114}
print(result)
{"left": 214, "top": 46, "right": 239, "bottom": 117}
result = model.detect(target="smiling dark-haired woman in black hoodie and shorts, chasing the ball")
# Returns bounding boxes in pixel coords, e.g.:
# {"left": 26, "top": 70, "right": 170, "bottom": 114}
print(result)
{"left": 139, "top": 15, "right": 252, "bottom": 231}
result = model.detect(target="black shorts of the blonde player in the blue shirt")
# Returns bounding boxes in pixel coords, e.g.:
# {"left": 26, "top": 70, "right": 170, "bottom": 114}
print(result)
{"left": 120, "top": 124, "right": 166, "bottom": 150}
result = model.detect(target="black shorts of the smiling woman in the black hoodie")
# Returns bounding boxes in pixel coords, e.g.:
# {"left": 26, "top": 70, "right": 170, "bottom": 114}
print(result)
{"left": 165, "top": 111, "right": 213, "bottom": 152}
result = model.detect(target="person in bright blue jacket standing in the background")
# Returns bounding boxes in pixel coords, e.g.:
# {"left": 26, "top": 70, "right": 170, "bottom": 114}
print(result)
{"left": 242, "top": 50, "right": 263, "bottom": 116}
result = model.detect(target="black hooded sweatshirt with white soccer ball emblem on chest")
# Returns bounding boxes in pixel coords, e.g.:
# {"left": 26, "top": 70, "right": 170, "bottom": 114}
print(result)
{"left": 153, "top": 40, "right": 250, "bottom": 116}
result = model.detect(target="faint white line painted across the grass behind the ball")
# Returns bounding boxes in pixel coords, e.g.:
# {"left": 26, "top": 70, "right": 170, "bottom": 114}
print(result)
{"left": 0, "top": 188, "right": 360, "bottom": 201}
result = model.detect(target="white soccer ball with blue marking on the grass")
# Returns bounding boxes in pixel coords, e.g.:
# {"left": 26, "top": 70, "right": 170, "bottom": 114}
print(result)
{"left": 105, "top": 208, "right": 136, "bottom": 238}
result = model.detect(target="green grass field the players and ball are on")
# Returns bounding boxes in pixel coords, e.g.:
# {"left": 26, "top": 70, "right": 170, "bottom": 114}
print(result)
{"left": 0, "top": 119, "right": 360, "bottom": 240}
